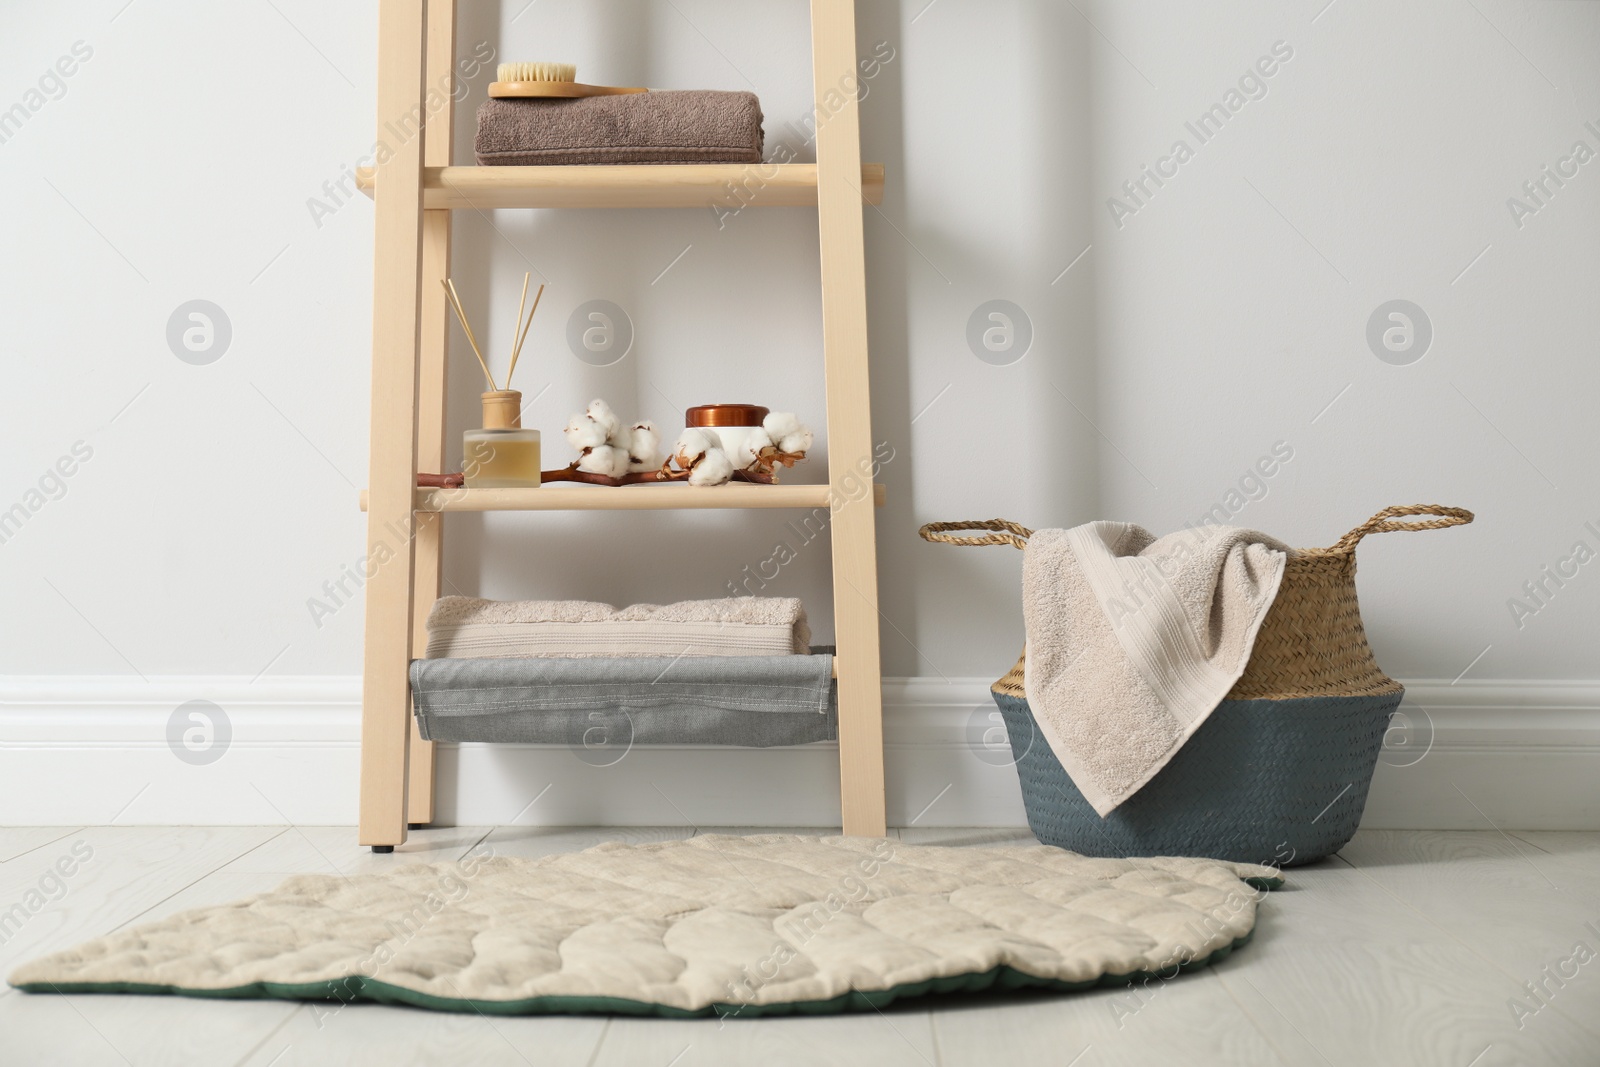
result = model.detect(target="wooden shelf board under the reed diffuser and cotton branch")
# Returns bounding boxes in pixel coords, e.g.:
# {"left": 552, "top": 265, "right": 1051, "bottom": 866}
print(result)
{"left": 362, "top": 483, "right": 886, "bottom": 512}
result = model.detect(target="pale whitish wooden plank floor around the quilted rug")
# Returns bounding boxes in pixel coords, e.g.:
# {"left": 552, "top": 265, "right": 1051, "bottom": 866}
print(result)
{"left": 0, "top": 827, "right": 1600, "bottom": 1067}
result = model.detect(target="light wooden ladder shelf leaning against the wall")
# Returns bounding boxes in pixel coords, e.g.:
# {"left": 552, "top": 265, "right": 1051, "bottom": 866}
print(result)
{"left": 360, "top": 0, "right": 885, "bottom": 851}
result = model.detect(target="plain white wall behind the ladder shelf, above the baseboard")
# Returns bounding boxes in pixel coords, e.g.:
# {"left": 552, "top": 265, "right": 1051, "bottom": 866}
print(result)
{"left": 0, "top": 0, "right": 1600, "bottom": 825}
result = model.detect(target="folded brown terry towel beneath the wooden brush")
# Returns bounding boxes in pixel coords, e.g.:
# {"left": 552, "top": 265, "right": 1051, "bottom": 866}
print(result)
{"left": 475, "top": 90, "right": 763, "bottom": 166}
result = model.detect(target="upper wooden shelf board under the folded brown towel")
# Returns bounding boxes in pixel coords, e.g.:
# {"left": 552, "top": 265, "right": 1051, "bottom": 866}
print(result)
{"left": 355, "top": 163, "right": 883, "bottom": 211}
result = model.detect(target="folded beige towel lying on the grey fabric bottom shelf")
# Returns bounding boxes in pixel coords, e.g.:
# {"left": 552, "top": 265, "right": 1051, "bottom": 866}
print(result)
{"left": 426, "top": 597, "right": 811, "bottom": 659}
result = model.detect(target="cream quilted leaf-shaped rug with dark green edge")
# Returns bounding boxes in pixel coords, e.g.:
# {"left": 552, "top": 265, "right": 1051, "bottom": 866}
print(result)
{"left": 0, "top": 833, "right": 1282, "bottom": 1017}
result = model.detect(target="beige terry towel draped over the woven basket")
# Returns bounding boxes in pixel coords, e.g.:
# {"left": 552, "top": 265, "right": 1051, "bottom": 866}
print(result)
{"left": 1022, "top": 522, "right": 1291, "bottom": 816}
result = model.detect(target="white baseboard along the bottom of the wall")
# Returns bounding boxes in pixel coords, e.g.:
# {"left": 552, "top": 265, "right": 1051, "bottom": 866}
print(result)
{"left": 0, "top": 677, "right": 1600, "bottom": 830}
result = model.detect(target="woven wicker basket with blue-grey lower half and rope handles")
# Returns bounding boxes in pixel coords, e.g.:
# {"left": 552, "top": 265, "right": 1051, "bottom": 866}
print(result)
{"left": 920, "top": 504, "right": 1472, "bottom": 867}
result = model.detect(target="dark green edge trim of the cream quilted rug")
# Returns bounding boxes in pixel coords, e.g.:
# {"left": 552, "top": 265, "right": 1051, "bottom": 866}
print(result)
{"left": 18, "top": 878, "right": 1283, "bottom": 1019}
